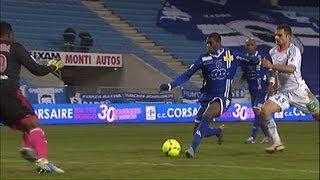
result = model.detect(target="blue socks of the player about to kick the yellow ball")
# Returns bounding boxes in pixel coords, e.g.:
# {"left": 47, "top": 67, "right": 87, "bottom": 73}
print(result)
{"left": 191, "top": 116, "right": 221, "bottom": 151}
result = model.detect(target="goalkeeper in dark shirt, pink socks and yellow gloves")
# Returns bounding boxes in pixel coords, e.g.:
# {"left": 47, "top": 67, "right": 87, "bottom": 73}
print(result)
{"left": 0, "top": 21, "right": 64, "bottom": 173}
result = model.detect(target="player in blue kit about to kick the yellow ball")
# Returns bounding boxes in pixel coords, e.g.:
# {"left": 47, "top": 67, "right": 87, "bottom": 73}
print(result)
{"left": 160, "top": 33, "right": 260, "bottom": 158}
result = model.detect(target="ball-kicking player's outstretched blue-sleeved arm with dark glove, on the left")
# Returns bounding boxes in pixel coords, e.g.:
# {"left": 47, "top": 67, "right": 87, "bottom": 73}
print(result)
{"left": 160, "top": 56, "right": 203, "bottom": 92}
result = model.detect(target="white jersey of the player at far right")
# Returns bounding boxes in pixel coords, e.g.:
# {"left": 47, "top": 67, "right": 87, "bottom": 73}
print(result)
{"left": 269, "top": 43, "right": 305, "bottom": 92}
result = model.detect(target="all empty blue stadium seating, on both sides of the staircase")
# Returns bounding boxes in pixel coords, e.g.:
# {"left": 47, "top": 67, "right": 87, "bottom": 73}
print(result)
{"left": 1, "top": 0, "right": 319, "bottom": 95}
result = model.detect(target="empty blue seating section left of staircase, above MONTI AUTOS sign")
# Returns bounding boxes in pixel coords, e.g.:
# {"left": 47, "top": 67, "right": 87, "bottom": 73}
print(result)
{"left": 1, "top": 0, "right": 196, "bottom": 88}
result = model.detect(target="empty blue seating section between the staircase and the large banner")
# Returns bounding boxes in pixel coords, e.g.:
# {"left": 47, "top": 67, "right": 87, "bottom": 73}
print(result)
{"left": 104, "top": 0, "right": 206, "bottom": 65}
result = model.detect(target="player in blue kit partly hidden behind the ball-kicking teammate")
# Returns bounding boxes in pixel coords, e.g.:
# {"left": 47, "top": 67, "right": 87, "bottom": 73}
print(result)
{"left": 235, "top": 38, "right": 271, "bottom": 144}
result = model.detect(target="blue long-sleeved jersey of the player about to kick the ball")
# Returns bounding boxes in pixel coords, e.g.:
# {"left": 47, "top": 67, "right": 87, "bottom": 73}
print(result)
{"left": 170, "top": 48, "right": 260, "bottom": 98}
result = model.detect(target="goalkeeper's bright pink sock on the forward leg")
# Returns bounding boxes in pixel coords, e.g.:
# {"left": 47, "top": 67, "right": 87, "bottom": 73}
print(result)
{"left": 29, "top": 127, "right": 48, "bottom": 159}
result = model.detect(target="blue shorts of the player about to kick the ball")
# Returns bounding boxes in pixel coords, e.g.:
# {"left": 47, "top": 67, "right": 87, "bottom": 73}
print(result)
{"left": 194, "top": 96, "right": 231, "bottom": 123}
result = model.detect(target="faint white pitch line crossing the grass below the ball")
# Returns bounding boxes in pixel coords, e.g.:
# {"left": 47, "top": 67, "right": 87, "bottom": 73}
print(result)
{"left": 1, "top": 159, "right": 319, "bottom": 174}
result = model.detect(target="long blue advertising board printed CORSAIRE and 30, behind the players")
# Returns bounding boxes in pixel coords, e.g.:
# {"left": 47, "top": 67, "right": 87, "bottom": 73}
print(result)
{"left": 34, "top": 103, "right": 313, "bottom": 124}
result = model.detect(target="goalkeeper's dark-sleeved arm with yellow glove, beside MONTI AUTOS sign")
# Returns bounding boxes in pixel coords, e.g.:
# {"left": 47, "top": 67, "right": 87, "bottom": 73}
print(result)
{"left": 15, "top": 44, "right": 63, "bottom": 76}
